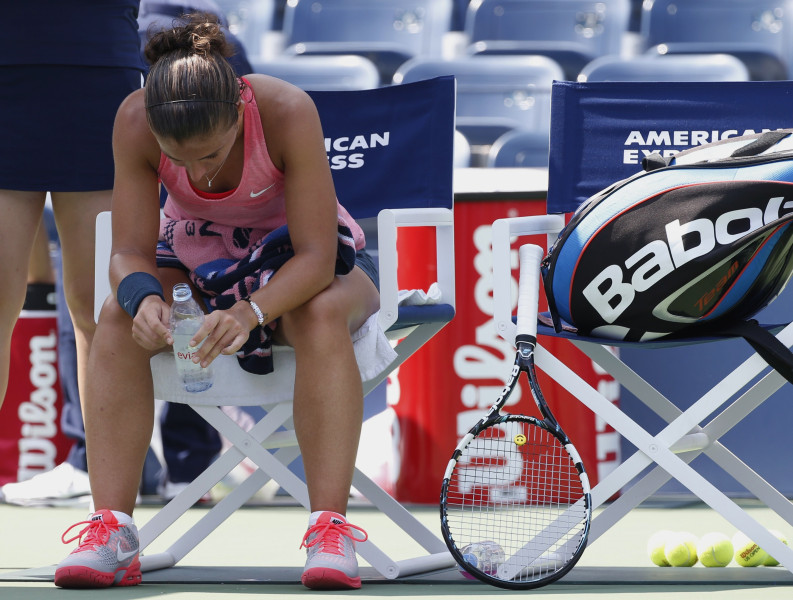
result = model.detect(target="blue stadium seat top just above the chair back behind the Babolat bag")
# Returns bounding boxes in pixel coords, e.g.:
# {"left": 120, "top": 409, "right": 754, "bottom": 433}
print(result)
{"left": 578, "top": 54, "right": 750, "bottom": 82}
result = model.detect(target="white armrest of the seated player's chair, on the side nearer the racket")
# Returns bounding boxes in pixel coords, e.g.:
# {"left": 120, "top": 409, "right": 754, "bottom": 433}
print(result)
{"left": 377, "top": 208, "right": 455, "bottom": 331}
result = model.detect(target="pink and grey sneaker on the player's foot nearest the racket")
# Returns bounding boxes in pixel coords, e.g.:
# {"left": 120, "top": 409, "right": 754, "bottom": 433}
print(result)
{"left": 300, "top": 511, "right": 368, "bottom": 590}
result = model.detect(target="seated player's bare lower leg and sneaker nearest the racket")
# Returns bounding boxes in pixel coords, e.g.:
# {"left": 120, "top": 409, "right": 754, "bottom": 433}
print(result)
{"left": 276, "top": 268, "right": 379, "bottom": 589}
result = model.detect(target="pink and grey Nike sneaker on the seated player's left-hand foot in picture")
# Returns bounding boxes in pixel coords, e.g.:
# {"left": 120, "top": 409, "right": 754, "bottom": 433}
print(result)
{"left": 55, "top": 510, "right": 141, "bottom": 588}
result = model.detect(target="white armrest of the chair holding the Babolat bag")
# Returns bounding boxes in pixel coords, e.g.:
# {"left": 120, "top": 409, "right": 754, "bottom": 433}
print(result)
{"left": 492, "top": 215, "right": 564, "bottom": 344}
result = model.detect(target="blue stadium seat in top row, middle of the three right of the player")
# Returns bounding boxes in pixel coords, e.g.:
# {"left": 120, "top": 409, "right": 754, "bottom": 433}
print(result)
{"left": 465, "top": 0, "right": 631, "bottom": 80}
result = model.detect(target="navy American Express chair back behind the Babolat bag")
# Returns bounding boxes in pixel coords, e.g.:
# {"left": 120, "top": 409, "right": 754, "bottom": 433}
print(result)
{"left": 547, "top": 81, "right": 793, "bottom": 213}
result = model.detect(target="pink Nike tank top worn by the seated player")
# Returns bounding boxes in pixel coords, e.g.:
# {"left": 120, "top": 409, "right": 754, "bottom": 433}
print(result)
{"left": 158, "top": 85, "right": 366, "bottom": 250}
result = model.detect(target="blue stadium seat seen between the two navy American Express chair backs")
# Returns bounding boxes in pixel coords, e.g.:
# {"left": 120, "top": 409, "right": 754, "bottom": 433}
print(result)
{"left": 394, "top": 56, "right": 564, "bottom": 146}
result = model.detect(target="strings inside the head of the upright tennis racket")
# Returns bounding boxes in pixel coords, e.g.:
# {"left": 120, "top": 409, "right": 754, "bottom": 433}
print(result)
{"left": 446, "top": 417, "right": 588, "bottom": 581}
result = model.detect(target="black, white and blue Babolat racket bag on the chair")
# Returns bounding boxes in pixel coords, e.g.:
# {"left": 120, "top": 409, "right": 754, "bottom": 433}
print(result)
{"left": 542, "top": 129, "right": 793, "bottom": 381}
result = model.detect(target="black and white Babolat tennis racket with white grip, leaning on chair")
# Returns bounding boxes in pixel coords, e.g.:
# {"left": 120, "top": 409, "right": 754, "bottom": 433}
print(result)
{"left": 441, "top": 245, "right": 592, "bottom": 589}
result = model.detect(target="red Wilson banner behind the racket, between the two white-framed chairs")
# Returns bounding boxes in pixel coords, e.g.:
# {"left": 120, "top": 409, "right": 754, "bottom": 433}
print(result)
{"left": 388, "top": 201, "right": 620, "bottom": 504}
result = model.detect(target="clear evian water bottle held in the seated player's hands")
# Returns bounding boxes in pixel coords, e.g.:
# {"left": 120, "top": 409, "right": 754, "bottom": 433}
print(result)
{"left": 171, "top": 283, "right": 214, "bottom": 392}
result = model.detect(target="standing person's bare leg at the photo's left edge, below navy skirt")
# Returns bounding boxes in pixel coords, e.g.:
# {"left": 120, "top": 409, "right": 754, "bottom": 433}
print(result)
{"left": 0, "top": 190, "right": 45, "bottom": 405}
